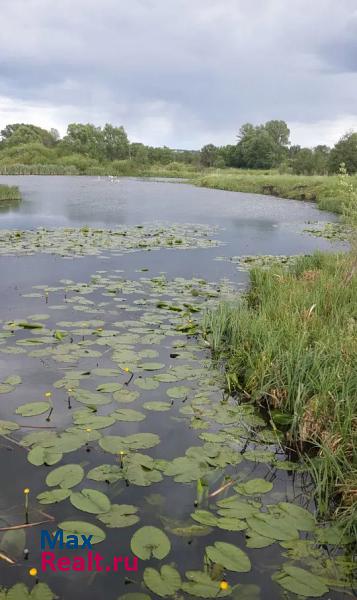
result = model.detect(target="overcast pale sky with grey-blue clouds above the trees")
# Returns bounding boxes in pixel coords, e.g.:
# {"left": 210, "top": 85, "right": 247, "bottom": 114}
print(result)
{"left": 0, "top": 0, "right": 357, "bottom": 148}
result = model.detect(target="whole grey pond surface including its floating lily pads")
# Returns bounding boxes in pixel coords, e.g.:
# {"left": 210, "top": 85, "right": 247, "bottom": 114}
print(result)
{"left": 0, "top": 177, "right": 347, "bottom": 600}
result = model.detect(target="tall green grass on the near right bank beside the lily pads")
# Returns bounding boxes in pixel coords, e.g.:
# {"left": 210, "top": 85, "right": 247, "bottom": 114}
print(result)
{"left": 204, "top": 253, "right": 357, "bottom": 534}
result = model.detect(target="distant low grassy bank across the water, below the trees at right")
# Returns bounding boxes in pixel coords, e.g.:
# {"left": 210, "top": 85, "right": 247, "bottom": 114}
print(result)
{"left": 193, "top": 169, "right": 357, "bottom": 213}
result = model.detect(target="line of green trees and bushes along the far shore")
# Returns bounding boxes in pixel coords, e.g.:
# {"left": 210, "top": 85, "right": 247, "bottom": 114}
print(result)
{"left": 0, "top": 120, "right": 357, "bottom": 175}
